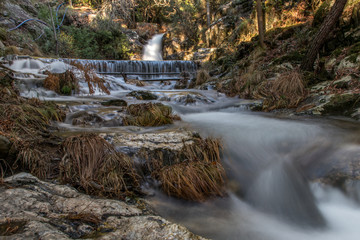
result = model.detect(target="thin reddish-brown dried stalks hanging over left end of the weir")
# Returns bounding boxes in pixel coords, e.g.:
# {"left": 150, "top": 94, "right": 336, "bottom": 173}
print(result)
{"left": 70, "top": 61, "right": 110, "bottom": 95}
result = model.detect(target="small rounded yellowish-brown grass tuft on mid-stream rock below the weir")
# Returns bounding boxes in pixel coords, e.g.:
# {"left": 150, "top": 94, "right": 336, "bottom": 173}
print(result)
{"left": 123, "top": 103, "right": 174, "bottom": 127}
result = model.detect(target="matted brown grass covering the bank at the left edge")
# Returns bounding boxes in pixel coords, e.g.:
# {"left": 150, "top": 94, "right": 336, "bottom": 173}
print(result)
{"left": 0, "top": 70, "right": 65, "bottom": 179}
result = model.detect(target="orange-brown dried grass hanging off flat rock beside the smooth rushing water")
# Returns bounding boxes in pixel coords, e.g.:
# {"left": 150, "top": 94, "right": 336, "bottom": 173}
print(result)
{"left": 140, "top": 138, "right": 225, "bottom": 201}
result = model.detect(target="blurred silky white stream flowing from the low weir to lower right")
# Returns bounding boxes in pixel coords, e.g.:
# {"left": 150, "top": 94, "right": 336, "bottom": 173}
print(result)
{"left": 6, "top": 56, "right": 360, "bottom": 240}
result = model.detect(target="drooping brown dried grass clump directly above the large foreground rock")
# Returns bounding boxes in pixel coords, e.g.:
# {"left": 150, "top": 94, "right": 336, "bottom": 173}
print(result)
{"left": 60, "top": 134, "right": 139, "bottom": 197}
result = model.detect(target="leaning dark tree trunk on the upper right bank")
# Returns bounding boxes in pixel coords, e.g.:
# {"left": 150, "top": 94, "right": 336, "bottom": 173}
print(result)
{"left": 300, "top": 0, "right": 347, "bottom": 71}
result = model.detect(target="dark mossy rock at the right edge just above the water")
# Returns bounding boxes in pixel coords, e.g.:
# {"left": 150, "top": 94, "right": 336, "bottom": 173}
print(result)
{"left": 322, "top": 94, "right": 360, "bottom": 116}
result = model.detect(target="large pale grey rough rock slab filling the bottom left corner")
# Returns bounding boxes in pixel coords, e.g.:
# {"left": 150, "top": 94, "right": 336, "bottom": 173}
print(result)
{"left": 0, "top": 173, "right": 204, "bottom": 240}
